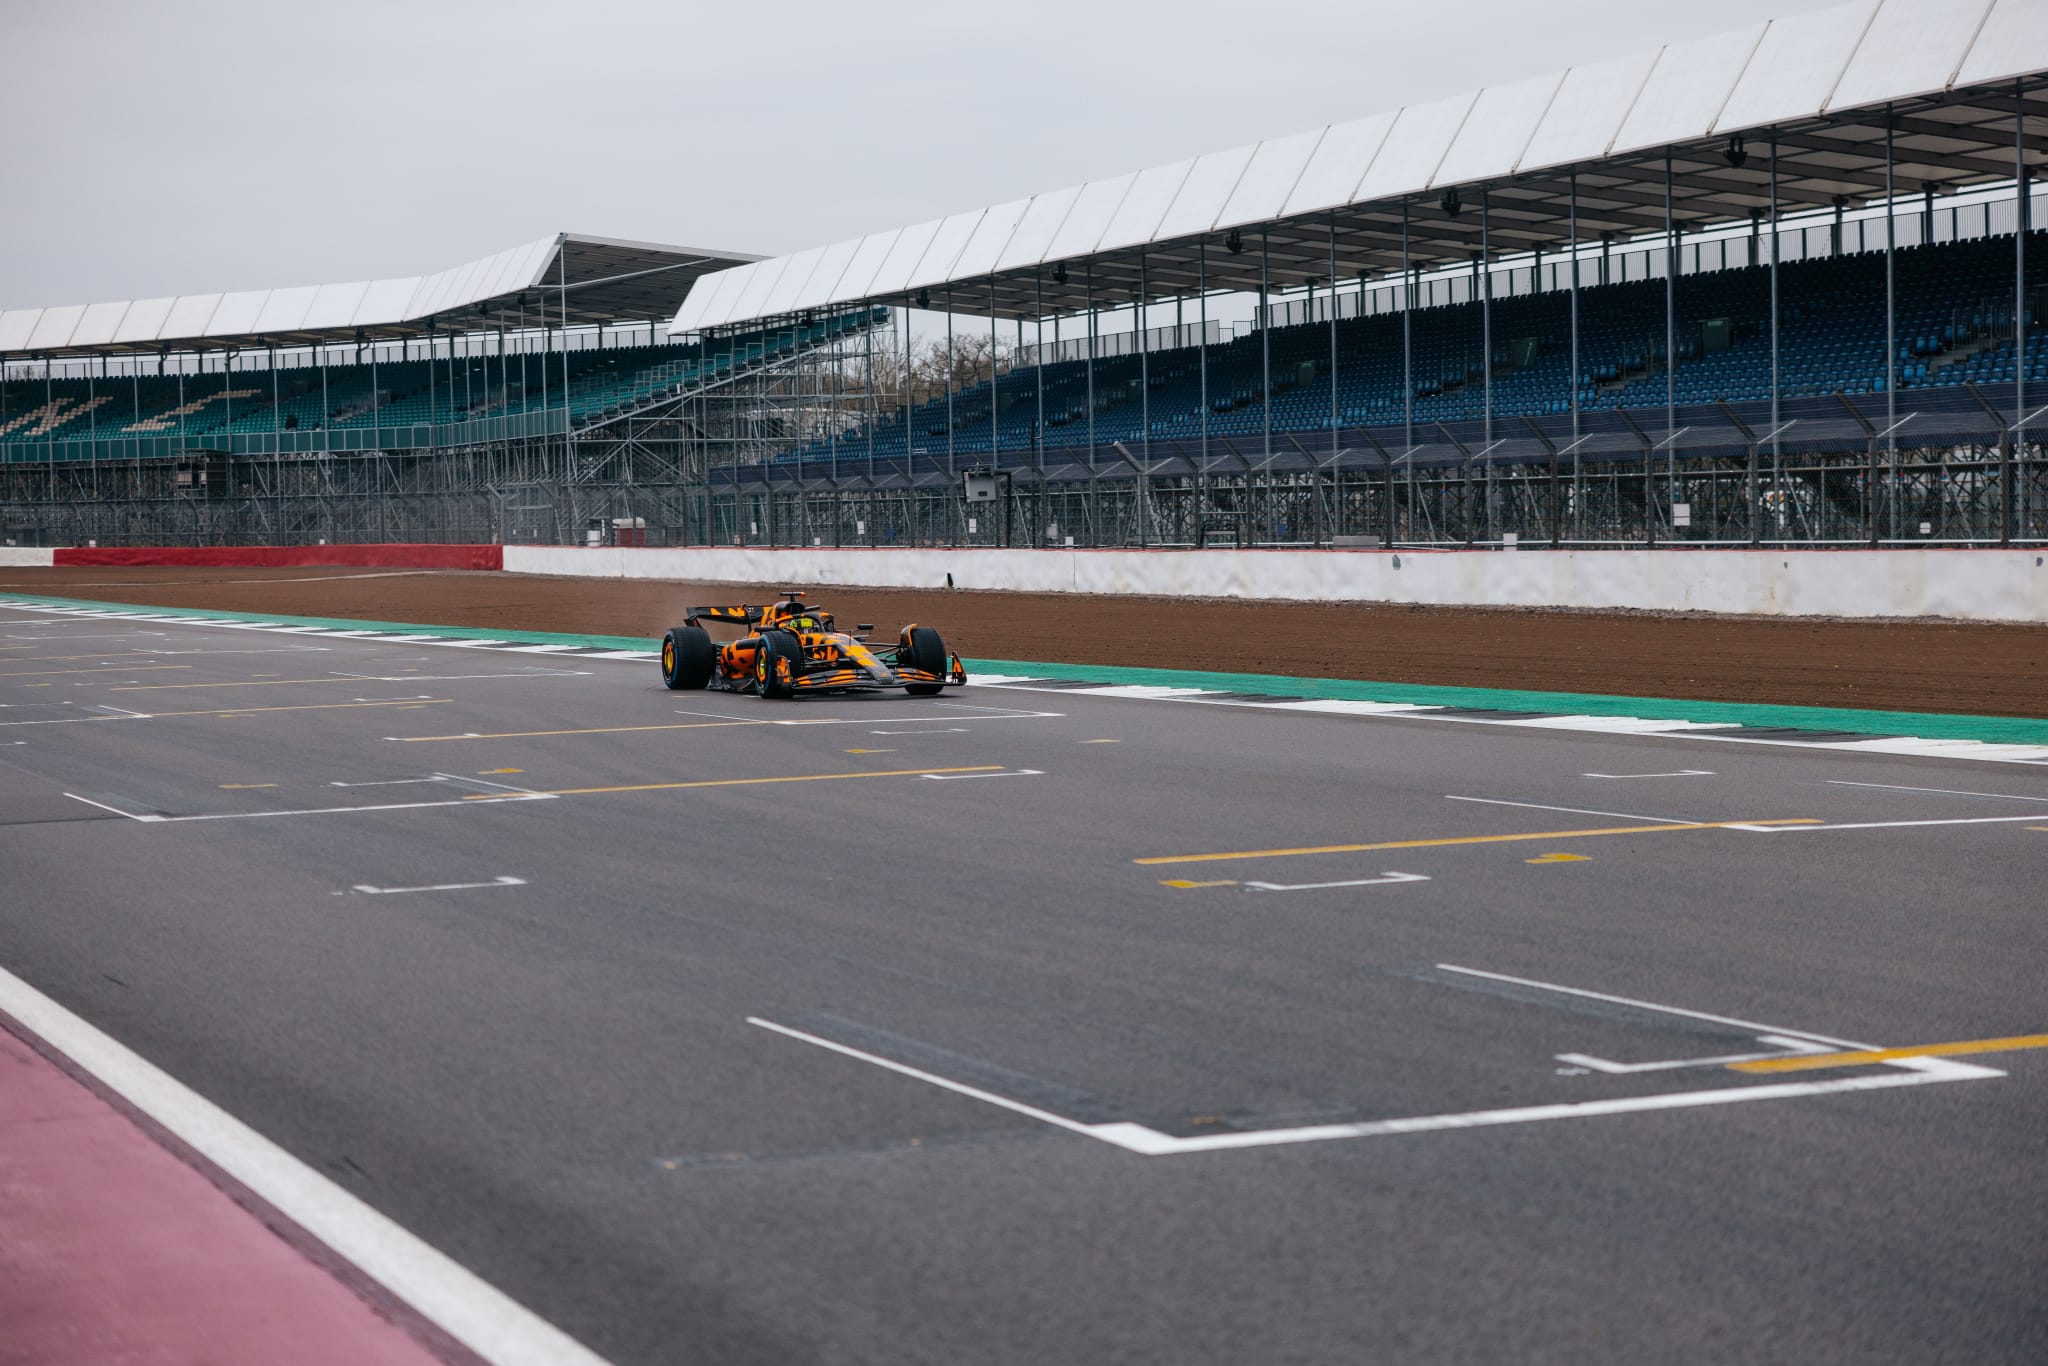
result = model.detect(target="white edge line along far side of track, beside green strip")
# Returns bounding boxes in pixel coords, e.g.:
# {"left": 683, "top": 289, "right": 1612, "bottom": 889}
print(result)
{"left": 0, "top": 600, "right": 2048, "bottom": 766}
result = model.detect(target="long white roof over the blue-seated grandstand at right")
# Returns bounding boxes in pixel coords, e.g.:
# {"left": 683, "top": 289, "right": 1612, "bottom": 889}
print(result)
{"left": 670, "top": 0, "right": 2048, "bottom": 332}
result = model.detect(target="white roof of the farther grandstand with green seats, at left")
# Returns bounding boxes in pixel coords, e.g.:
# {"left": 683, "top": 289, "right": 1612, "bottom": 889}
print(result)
{"left": 0, "top": 233, "right": 760, "bottom": 356}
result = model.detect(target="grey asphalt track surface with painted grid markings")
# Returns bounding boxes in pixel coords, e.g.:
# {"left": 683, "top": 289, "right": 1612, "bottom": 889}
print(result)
{"left": 0, "top": 610, "right": 2048, "bottom": 1364}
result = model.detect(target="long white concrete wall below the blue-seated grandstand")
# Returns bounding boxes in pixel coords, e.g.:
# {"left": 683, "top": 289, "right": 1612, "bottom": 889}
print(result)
{"left": 506, "top": 545, "right": 2048, "bottom": 623}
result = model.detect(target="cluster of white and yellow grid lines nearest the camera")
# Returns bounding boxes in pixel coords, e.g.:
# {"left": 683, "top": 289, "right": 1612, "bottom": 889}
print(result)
{"left": 748, "top": 963, "right": 2015, "bottom": 1157}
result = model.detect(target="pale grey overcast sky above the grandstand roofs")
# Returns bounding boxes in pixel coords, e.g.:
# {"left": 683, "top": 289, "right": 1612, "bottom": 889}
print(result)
{"left": 0, "top": 0, "right": 1823, "bottom": 307}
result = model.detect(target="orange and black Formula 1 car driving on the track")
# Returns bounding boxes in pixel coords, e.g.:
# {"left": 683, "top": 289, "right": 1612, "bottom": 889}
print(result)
{"left": 662, "top": 592, "right": 967, "bottom": 698}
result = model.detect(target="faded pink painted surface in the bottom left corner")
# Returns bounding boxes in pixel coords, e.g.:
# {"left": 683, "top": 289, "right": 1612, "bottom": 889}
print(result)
{"left": 0, "top": 1028, "right": 438, "bottom": 1366}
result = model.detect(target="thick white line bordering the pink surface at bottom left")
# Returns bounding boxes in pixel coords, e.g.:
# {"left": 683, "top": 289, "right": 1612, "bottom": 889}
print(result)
{"left": 0, "top": 969, "right": 606, "bottom": 1366}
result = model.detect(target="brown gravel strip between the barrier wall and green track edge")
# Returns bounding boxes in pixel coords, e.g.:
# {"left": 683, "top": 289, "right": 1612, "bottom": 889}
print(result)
{"left": 0, "top": 567, "right": 2048, "bottom": 717}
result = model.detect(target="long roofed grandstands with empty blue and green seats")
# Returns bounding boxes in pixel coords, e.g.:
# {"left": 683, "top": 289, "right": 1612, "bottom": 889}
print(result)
{"left": 0, "top": 0, "right": 2048, "bottom": 545}
